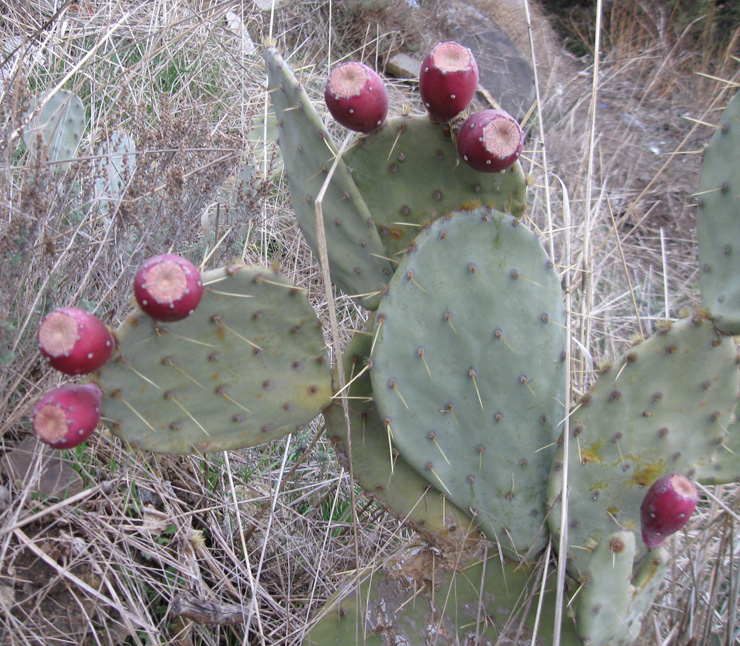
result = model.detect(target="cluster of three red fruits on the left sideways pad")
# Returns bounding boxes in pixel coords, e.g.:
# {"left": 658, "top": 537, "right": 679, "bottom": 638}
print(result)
{"left": 33, "top": 254, "right": 203, "bottom": 449}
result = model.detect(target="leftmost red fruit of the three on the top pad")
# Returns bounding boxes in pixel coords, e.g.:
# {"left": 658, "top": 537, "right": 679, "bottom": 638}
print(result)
{"left": 324, "top": 62, "right": 388, "bottom": 133}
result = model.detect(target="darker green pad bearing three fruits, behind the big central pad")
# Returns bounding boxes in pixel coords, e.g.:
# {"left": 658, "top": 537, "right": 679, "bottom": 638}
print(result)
{"left": 344, "top": 116, "right": 527, "bottom": 259}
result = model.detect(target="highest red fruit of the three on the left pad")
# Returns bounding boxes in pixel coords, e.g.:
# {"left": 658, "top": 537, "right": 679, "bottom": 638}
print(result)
{"left": 134, "top": 254, "right": 203, "bottom": 323}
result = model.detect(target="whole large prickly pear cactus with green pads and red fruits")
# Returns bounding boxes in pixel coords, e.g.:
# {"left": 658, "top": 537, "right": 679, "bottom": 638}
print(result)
{"left": 34, "top": 43, "right": 740, "bottom": 646}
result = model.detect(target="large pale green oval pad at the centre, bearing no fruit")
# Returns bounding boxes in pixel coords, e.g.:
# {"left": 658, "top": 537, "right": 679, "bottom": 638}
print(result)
{"left": 371, "top": 208, "right": 566, "bottom": 558}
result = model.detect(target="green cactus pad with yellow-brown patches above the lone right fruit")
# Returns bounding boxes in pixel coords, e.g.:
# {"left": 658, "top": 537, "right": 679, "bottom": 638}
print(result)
{"left": 548, "top": 316, "right": 740, "bottom": 576}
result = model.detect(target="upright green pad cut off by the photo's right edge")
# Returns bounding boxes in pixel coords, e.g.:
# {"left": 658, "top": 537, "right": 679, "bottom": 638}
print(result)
{"left": 696, "top": 94, "right": 740, "bottom": 335}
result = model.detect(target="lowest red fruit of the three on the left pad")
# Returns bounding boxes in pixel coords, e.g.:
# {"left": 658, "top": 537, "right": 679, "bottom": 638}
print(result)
{"left": 33, "top": 384, "right": 103, "bottom": 449}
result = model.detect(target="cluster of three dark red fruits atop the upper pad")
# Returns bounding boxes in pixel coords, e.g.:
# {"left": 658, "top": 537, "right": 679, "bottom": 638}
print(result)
{"left": 324, "top": 42, "right": 524, "bottom": 173}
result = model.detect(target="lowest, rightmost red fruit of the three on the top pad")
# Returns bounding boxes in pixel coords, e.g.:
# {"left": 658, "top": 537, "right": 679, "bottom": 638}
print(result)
{"left": 457, "top": 110, "right": 524, "bottom": 173}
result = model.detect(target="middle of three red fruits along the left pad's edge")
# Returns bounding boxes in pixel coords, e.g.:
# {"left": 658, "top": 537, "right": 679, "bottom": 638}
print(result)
{"left": 38, "top": 307, "right": 116, "bottom": 375}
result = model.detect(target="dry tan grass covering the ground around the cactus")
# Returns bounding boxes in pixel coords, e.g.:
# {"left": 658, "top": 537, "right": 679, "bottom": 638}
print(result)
{"left": 0, "top": 0, "right": 740, "bottom": 646}
